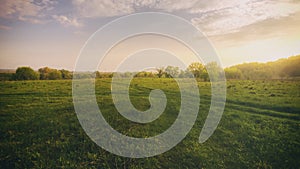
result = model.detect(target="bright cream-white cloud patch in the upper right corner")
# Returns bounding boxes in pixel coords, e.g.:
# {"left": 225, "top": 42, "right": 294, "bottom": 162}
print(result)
{"left": 190, "top": 0, "right": 300, "bottom": 36}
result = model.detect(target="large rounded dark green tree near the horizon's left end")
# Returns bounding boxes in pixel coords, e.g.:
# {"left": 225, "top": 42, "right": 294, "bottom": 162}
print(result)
{"left": 14, "top": 67, "right": 39, "bottom": 80}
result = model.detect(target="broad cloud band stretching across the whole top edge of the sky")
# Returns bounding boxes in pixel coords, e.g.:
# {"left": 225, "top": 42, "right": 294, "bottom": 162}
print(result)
{"left": 0, "top": 0, "right": 300, "bottom": 32}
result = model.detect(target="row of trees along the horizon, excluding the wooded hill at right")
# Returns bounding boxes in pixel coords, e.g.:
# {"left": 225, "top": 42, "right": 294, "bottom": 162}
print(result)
{"left": 10, "top": 62, "right": 221, "bottom": 81}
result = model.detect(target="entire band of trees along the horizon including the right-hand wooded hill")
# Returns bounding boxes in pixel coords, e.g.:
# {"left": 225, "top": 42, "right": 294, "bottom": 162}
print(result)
{"left": 0, "top": 55, "right": 300, "bottom": 81}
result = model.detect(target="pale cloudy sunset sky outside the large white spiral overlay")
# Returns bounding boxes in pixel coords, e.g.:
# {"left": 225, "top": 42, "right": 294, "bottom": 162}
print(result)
{"left": 0, "top": 0, "right": 300, "bottom": 71}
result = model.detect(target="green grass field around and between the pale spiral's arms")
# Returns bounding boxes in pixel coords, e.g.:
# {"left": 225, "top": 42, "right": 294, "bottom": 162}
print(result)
{"left": 0, "top": 78, "right": 300, "bottom": 169}
